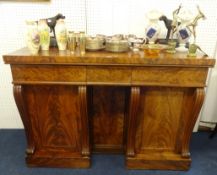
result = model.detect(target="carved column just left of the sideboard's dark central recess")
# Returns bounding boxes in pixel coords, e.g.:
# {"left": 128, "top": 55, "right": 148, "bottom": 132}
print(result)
{"left": 78, "top": 86, "right": 90, "bottom": 156}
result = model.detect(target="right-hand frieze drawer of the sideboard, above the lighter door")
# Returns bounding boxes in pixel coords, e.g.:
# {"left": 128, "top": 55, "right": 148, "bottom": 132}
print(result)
{"left": 132, "top": 67, "right": 208, "bottom": 87}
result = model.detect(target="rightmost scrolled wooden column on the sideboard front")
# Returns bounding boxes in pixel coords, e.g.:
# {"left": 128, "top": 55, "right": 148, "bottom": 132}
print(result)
{"left": 182, "top": 88, "right": 205, "bottom": 158}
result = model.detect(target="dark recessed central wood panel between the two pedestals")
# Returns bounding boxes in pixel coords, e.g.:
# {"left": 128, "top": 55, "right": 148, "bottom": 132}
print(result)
{"left": 91, "top": 86, "right": 126, "bottom": 153}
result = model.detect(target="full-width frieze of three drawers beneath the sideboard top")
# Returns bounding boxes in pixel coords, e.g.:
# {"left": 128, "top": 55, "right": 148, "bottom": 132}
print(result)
{"left": 11, "top": 65, "right": 208, "bottom": 87}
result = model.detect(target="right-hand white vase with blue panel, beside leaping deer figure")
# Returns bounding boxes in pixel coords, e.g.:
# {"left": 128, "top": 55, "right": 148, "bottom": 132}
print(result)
{"left": 176, "top": 8, "right": 193, "bottom": 52}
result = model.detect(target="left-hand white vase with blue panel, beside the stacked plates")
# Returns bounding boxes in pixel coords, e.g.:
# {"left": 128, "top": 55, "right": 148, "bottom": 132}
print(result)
{"left": 146, "top": 10, "right": 162, "bottom": 44}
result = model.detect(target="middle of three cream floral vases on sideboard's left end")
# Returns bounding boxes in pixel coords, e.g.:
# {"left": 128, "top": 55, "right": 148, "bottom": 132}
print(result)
{"left": 38, "top": 19, "right": 50, "bottom": 50}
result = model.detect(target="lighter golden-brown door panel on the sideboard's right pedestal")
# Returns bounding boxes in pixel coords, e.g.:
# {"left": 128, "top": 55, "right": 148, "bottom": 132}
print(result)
{"left": 136, "top": 87, "right": 186, "bottom": 153}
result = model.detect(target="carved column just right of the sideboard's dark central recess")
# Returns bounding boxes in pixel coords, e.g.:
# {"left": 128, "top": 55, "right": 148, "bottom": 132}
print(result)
{"left": 126, "top": 87, "right": 140, "bottom": 157}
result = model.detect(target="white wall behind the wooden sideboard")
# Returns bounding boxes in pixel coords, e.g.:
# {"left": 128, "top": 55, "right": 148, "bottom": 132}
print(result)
{"left": 0, "top": 0, "right": 217, "bottom": 128}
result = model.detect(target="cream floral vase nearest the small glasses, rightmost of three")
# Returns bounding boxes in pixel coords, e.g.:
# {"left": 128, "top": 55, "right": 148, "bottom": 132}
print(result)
{"left": 55, "top": 19, "right": 67, "bottom": 50}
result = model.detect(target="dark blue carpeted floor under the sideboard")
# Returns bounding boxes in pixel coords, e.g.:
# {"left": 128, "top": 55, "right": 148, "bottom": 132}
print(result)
{"left": 0, "top": 130, "right": 217, "bottom": 175}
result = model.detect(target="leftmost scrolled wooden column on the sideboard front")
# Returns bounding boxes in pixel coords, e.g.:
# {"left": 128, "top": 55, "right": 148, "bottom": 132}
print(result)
{"left": 13, "top": 85, "right": 35, "bottom": 155}
